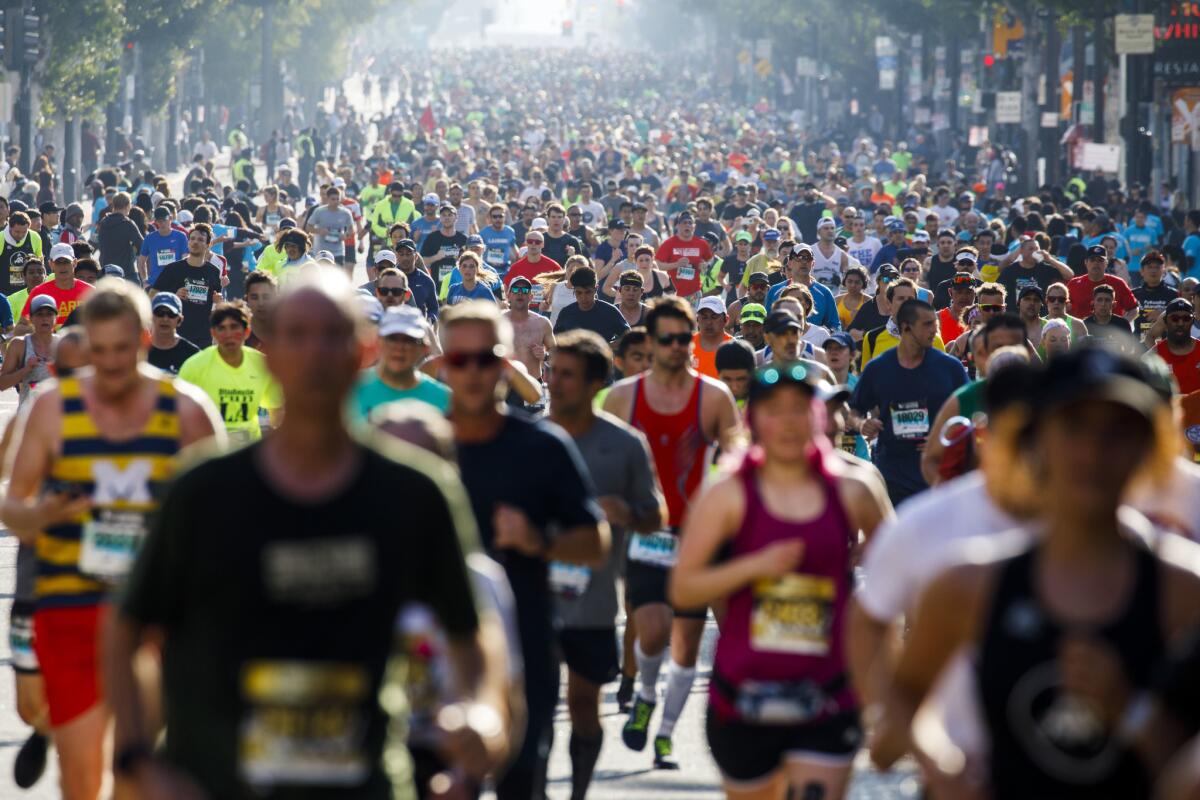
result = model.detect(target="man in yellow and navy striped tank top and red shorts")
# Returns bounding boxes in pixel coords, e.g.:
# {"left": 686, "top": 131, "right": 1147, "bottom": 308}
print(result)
{"left": 0, "top": 278, "right": 222, "bottom": 800}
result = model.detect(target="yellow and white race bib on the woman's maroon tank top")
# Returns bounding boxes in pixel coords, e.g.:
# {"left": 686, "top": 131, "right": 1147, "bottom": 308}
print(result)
{"left": 750, "top": 575, "right": 838, "bottom": 656}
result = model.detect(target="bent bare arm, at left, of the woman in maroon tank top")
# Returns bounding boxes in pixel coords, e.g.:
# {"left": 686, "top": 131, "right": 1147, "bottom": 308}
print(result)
{"left": 667, "top": 475, "right": 804, "bottom": 608}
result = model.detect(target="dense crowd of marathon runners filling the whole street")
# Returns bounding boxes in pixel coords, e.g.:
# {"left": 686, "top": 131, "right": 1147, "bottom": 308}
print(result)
{"left": 0, "top": 52, "right": 1200, "bottom": 800}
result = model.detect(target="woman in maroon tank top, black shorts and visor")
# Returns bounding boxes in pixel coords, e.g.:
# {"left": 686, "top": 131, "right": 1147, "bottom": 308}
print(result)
{"left": 671, "top": 363, "right": 890, "bottom": 800}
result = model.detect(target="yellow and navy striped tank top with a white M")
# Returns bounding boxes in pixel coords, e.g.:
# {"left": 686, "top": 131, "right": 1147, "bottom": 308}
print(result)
{"left": 34, "top": 378, "right": 180, "bottom": 608}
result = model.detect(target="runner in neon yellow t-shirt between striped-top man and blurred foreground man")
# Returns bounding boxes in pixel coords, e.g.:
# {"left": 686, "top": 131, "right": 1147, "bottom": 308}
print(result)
{"left": 179, "top": 300, "right": 283, "bottom": 444}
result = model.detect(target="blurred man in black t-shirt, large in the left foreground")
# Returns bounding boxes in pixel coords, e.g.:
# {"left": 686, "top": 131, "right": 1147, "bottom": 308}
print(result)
{"left": 106, "top": 270, "right": 509, "bottom": 798}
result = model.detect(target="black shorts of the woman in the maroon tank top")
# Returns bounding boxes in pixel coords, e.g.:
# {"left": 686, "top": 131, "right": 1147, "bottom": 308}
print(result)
{"left": 704, "top": 705, "right": 863, "bottom": 783}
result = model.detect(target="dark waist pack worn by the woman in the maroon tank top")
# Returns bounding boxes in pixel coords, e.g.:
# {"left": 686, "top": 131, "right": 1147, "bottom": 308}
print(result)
{"left": 712, "top": 672, "right": 848, "bottom": 724}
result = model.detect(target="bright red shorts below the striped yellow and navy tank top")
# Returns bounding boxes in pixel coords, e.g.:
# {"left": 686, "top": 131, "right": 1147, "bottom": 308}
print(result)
{"left": 34, "top": 606, "right": 108, "bottom": 728}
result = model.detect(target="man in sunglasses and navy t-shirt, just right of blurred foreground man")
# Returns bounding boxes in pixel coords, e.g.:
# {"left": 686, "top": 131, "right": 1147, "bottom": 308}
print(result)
{"left": 442, "top": 301, "right": 608, "bottom": 800}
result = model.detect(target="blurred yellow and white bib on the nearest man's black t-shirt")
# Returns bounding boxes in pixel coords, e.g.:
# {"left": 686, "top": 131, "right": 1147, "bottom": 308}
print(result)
{"left": 238, "top": 661, "right": 371, "bottom": 788}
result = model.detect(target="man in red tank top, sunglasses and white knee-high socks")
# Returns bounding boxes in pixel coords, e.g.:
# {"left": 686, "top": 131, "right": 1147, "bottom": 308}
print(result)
{"left": 604, "top": 296, "right": 738, "bottom": 769}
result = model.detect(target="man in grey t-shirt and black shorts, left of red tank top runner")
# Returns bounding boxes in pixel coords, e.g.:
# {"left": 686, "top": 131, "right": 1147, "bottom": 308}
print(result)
{"left": 547, "top": 331, "right": 666, "bottom": 800}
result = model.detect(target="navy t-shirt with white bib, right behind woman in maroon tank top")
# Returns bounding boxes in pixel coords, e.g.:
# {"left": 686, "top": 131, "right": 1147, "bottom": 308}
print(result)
{"left": 850, "top": 348, "right": 967, "bottom": 494}
